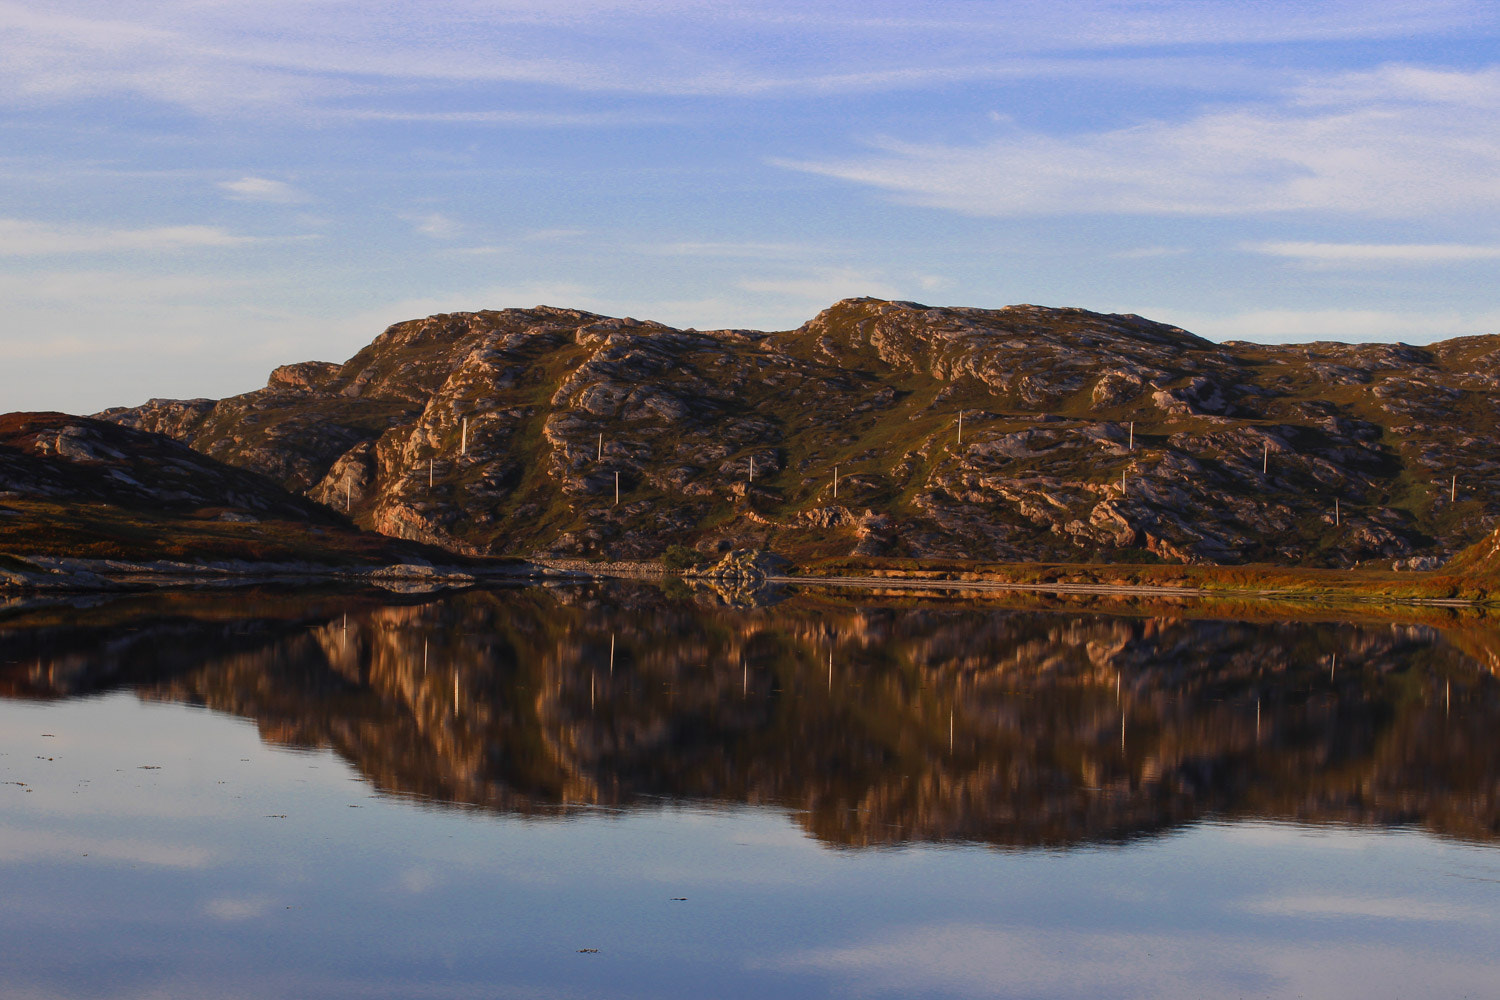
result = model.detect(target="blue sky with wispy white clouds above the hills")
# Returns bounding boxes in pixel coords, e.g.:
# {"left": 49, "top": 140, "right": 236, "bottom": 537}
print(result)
{"left": 0, "top": 0, "right": 1500, "bottom": 412}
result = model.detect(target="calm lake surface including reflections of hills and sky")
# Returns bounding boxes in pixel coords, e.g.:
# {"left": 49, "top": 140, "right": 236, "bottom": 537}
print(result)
{"left": 0, "top": 585, "right": 1500, "bottom": 999}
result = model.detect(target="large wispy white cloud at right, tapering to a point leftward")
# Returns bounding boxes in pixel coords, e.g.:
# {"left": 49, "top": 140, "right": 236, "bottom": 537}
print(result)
{"left": 773, "top": 67, "right": 1500, "bottom": 217}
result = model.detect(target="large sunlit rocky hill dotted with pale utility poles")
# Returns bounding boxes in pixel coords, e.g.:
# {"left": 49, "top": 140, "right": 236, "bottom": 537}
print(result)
{"left": 101, "top": 300, "right": 1500, "bottom": 565}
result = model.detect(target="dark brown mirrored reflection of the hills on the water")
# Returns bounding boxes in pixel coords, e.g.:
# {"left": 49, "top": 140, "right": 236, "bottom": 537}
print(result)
{"left": 0, "top": 591, "right": 1500, "bottom": 846}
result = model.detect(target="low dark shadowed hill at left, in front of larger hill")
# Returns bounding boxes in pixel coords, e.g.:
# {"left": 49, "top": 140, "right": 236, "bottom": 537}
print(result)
{"left": 0, "top": 414, "right": 438, "bottom": 570}
